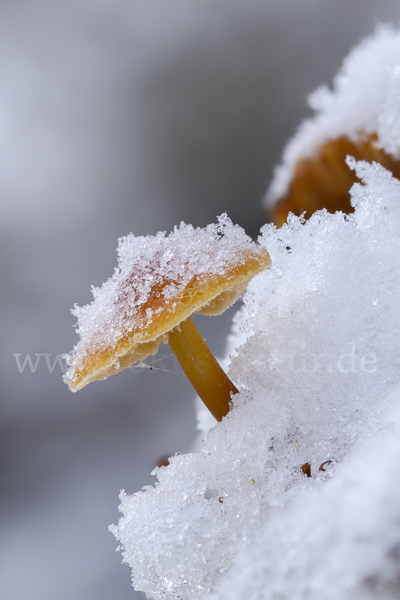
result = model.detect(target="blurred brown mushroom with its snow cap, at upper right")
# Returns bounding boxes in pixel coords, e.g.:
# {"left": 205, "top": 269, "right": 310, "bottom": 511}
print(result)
{"left": 266, "top": 27, "right": 400, "bottom": 225}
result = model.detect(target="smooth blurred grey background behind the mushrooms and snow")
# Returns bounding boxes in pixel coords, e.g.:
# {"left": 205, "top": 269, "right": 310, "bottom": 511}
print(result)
{"left": 0, "top": 0, "right": 400, "bottom": 600}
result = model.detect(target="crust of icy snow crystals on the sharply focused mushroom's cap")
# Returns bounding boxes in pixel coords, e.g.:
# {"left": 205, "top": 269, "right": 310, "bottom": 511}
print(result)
{"left": 64, "top": 214, "right": 255, "bottom": 383}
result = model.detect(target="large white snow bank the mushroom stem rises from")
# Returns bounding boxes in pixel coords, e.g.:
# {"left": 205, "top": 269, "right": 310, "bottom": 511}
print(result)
{"left": 110, "top": 159, "right": 400, "bottom": 600}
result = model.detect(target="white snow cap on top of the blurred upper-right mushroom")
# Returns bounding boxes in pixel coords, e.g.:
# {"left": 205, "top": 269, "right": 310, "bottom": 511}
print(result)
{"left": 265, "top": 26, "right": 400, "bottom": 207}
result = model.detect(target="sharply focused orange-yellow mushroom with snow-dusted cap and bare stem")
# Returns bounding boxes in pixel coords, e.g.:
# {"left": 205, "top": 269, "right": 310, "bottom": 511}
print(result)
{"left": 64, "top": 214, "right": 270, "bottom": 421}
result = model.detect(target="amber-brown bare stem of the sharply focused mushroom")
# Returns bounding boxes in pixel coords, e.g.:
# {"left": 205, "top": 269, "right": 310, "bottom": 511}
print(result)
{"left": 169, "top": 318, "right": 238, "bottom": 421}
